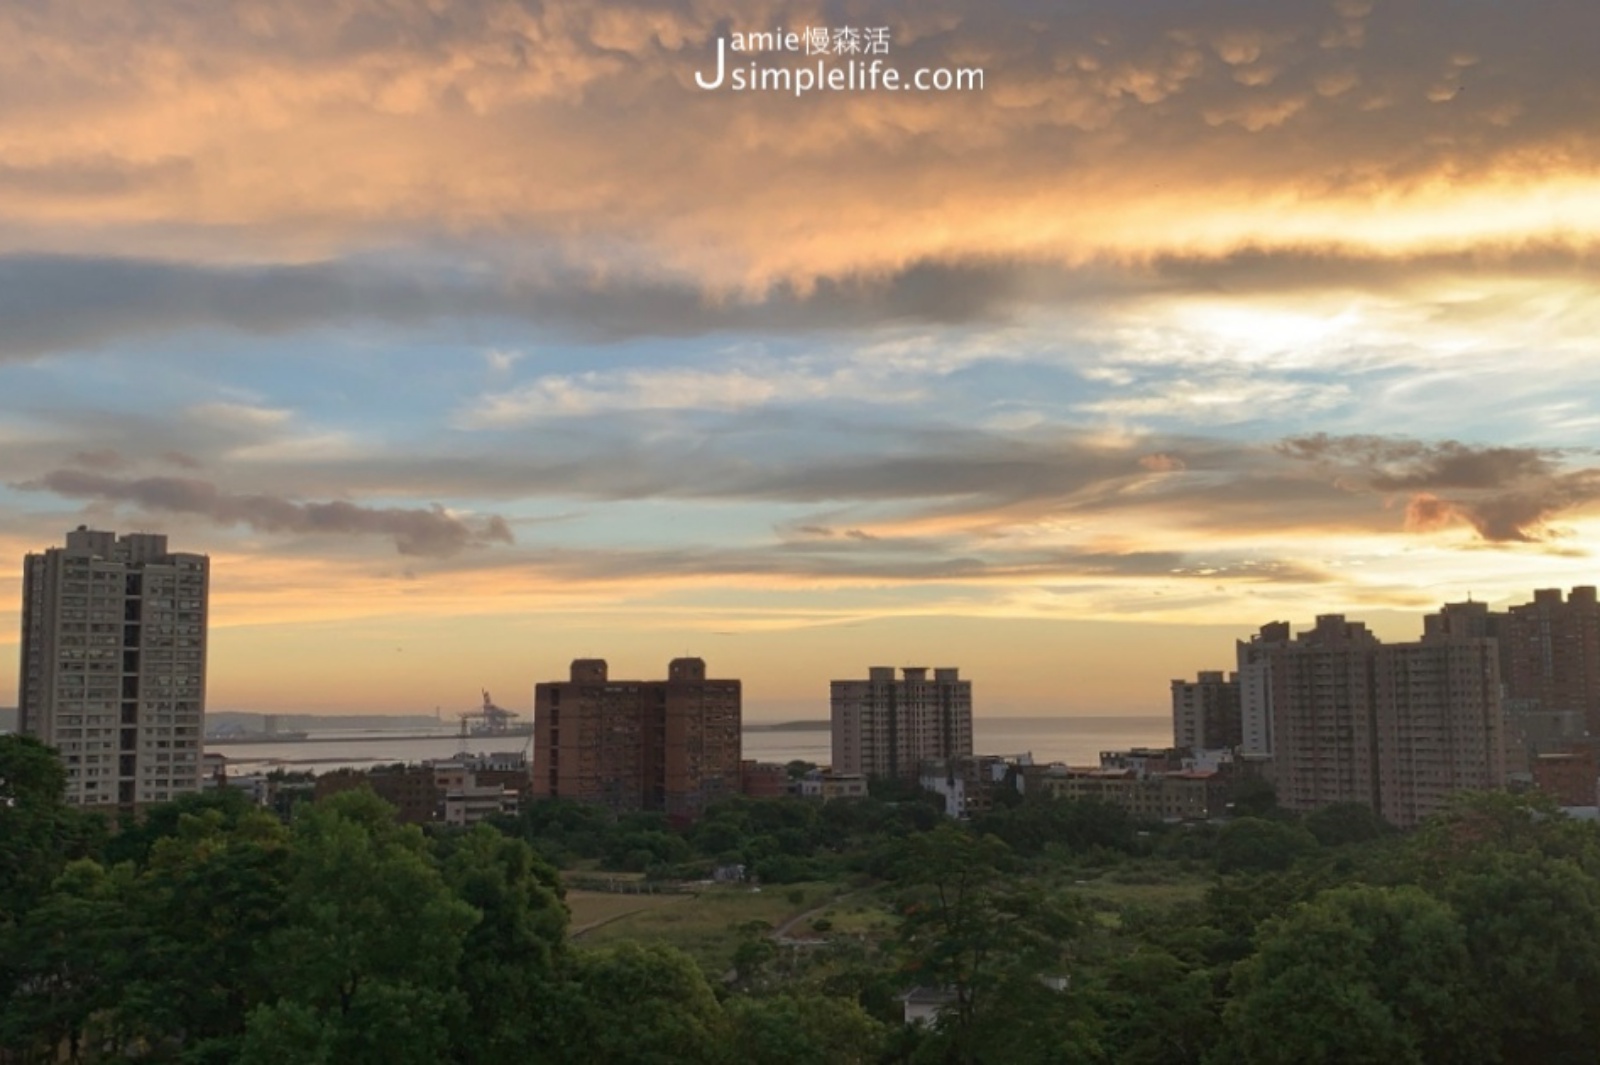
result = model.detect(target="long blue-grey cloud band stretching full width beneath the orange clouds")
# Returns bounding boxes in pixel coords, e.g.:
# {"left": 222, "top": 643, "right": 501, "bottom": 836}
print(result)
{"left": 12, "top": 236, "right": 1600, "bottom": 360}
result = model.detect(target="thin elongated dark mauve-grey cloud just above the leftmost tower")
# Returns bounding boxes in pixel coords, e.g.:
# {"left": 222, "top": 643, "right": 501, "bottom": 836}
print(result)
{"left": 16, "top": 470, "right": 514, "bottom": 556}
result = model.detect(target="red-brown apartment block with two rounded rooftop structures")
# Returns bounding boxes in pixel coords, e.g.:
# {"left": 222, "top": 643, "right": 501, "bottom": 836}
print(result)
{"left": 531, "top": 659, "right": 742, "bottom": 817}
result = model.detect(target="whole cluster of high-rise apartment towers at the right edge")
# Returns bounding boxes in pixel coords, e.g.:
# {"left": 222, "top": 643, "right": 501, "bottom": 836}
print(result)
{"left": 1171, "top": 587, "right": 1600, "bottom": 827}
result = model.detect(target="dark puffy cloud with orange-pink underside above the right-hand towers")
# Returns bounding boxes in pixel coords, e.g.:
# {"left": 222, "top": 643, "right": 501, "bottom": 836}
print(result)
{"left": 1282, "top": 433, "right": 1600, "bottom": 544}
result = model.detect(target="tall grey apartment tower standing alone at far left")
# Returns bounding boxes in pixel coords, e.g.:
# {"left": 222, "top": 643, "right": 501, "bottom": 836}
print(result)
{"left": 19, "top": 526, "right": 210, "bottom": 806}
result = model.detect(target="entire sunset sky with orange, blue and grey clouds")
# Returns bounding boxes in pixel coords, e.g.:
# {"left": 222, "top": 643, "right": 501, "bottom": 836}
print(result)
{"left": 0, "top": 0, "right": 1600, "bottom": 720}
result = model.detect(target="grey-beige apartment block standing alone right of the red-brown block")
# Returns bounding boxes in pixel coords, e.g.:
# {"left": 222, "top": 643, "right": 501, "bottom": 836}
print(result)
{"left": 830, "top": 665, "right": 973, "bottom": 780}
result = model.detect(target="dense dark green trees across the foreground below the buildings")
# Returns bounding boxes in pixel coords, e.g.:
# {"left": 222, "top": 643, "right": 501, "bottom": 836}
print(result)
{"left": 0, "top": 737, "right": 1600, "bottom": 1065}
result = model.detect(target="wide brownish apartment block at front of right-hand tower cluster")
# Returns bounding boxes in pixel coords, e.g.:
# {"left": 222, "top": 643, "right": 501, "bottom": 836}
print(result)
{"left": 1240, "top": 614, "right": 1506, "bottom": 827}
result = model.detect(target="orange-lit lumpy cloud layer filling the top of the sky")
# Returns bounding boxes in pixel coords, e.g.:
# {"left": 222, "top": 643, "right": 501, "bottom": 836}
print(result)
{"left": 0, "top": 0, "right": 1600, "bottom": 293}
